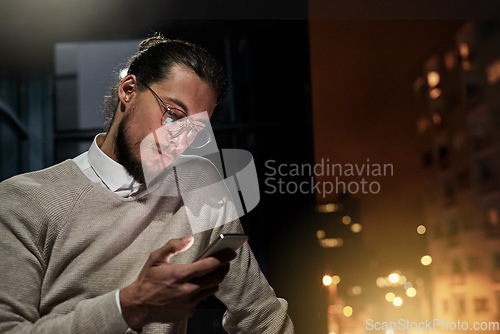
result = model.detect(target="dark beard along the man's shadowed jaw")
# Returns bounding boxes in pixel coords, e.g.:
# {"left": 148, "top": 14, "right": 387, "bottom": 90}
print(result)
{"left": 115, "top": 114, "right": 145, "bottom": 184}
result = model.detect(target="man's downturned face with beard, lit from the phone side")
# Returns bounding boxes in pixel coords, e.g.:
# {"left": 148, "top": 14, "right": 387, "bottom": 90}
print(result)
{"left": 115, "top": 65, "right": 216, "bottom": 183}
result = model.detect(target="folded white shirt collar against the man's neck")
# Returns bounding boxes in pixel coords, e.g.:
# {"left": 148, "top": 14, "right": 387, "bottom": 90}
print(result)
{"left": 88, "top": 133, "right": 139, "bottom": 192}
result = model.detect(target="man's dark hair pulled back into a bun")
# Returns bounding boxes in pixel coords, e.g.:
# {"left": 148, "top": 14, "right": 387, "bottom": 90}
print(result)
{"left": 104, "top": 34, "right": 227, "bottom": 127}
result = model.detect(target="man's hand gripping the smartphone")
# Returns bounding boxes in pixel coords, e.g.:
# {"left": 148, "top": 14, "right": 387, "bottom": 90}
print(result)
{"left": 120, "top": 236, "right": 236, "bottom": 330}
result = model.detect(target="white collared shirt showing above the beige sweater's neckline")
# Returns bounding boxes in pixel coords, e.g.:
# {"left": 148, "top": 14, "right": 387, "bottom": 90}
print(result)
{"left": 73, "top": 133, "right": 141, "bottom": 198}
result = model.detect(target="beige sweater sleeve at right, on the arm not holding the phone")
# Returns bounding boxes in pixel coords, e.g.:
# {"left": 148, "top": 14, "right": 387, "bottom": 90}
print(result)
{"left": 216, "top": 221, "right": 294, "bottom": 334}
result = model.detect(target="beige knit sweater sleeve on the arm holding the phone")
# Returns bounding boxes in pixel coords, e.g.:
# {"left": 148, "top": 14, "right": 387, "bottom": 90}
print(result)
{"left": 0, "top": 179, "right": 131, "bottom": 334}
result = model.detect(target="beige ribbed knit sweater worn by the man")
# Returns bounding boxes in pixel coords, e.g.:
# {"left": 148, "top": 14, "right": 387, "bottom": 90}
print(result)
{"left": 0, "top": 160, "right": 293, "bottom": 334}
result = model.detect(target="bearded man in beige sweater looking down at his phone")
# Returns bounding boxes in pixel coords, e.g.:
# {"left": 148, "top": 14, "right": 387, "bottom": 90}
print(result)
{"left": 0, "top": 36, "right": 293, "bottom": 334}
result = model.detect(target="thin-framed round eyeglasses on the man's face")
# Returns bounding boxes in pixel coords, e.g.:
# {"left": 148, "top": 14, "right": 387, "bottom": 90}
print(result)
{"left": 140, "top": 80, "right": 212, "bottom": 148}
